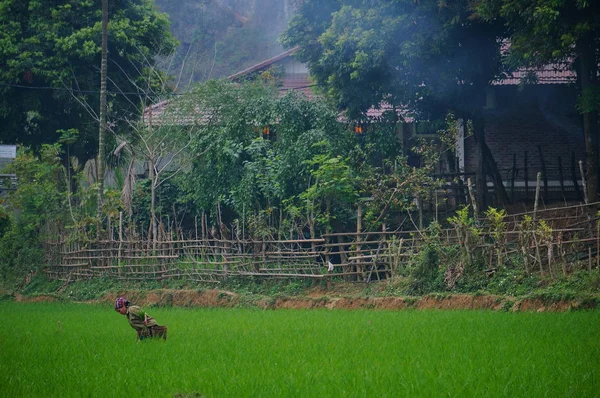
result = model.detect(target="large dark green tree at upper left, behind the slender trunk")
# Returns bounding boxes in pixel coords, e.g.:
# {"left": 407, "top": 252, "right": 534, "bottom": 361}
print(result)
{"left": 0, "top": 0, "right": 176, "bottom": 163}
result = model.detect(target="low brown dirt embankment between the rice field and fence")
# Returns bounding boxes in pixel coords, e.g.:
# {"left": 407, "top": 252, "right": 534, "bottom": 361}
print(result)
{"left": 15, "top": 289, "right": 584, "bottom": 312}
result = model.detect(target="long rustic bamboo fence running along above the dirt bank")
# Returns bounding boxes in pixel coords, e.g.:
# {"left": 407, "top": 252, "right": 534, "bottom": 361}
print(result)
{"left": 46, "top": 204, "right": 600, "bottom": 287}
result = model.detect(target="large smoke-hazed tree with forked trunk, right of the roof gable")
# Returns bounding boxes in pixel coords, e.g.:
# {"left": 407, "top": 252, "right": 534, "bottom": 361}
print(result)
{"left": 283, "top": 0, "right": 508, "bottom": 208}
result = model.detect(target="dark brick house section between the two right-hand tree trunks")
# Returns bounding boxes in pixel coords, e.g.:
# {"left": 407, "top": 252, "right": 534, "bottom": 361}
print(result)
{"left": 466, "top": 65, "right": 585, "bottom": 201}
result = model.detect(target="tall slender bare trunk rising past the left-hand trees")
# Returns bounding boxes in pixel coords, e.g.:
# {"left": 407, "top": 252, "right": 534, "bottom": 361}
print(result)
{"left": 96, "top": 0, "right": 108, "bottom": 237}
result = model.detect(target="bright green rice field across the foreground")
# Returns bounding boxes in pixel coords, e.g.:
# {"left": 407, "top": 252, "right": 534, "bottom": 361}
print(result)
{"left": 0, "top": 302, "right": 600, "bottom": 397}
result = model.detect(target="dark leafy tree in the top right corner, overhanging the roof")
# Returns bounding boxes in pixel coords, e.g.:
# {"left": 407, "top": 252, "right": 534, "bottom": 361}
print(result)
{"left": 478, "top": 0, "right": 600, "bottom": 201}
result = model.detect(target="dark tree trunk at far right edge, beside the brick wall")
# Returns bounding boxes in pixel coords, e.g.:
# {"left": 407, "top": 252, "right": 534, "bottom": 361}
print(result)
{"left": 578, "top": 42, "right": 599, "bottom": 202}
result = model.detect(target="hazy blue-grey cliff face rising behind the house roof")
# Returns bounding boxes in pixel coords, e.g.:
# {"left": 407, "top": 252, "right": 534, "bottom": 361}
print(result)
{"left": 156, "top": 0, "right": 295, "bottom": 90}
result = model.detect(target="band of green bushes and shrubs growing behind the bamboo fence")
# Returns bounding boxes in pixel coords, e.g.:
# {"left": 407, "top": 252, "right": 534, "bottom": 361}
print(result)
{"left": 1, "top": 77, "right": 438, "bottom": 282}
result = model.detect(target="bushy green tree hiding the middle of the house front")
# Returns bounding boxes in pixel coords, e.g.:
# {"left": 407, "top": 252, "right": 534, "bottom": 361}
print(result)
{"left": 171, "top": 79, "right": 353, "bottom": 238}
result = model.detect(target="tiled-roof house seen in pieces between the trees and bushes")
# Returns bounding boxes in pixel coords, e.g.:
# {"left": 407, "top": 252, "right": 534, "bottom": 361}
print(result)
{"left": 144, "top": 47, "right": 585, "bottom": 204}
